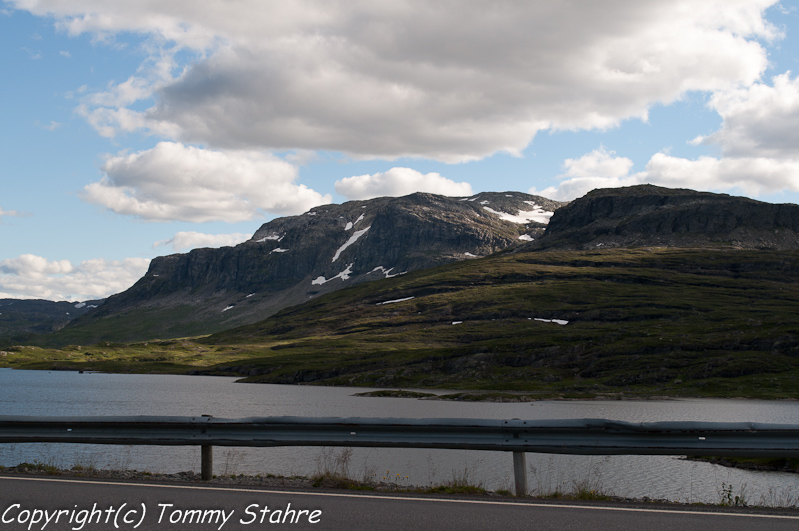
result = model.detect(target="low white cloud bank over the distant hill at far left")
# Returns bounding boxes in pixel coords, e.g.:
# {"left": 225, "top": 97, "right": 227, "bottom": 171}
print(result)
{"left": 0, "top": 254, "right": 150, "bottom": 301}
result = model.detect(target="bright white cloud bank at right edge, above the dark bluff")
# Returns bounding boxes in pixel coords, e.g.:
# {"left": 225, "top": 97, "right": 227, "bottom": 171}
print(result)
{"left": 531, "top": 72, "right": 799, "bottom": 199}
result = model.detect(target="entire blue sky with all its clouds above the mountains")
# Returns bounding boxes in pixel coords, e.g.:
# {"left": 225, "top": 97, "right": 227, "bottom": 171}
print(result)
{"left": 0, "top": 0, "right": 799, "bottom": 301}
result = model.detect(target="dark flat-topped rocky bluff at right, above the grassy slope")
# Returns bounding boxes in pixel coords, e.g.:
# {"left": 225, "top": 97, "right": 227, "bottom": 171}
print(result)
{"left": 533, "top": 185, "right": 799, "bottom": 250}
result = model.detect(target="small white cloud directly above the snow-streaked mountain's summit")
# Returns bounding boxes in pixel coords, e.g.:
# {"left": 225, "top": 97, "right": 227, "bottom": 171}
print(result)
{"left": 335, "top": 168, "right": 472, "bottom": 199}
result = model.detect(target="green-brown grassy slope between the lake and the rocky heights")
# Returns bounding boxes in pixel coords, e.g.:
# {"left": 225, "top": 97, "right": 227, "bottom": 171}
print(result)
{"left": 0, "top": 249, "right": 799, "bottom": 398}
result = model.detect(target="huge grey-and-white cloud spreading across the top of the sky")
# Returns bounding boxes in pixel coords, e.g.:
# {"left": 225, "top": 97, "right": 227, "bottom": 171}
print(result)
{"left": 12, "top": 0, "right": 780, "bottom": 162}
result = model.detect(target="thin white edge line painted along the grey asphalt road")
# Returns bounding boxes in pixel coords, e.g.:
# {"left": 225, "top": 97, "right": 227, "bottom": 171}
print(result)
{"left": 6, "top": 476, "right": 799, "bottom": 520}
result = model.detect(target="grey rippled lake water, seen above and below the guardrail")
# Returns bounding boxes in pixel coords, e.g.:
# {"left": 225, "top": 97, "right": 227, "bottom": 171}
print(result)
{"left": 0, "top": 369, "right": 799, "bottom": 503}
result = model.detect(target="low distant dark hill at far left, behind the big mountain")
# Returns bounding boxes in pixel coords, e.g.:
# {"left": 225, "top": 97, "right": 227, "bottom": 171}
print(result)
{"left": 0, "top": 299, "right": 103, "bottom": 344}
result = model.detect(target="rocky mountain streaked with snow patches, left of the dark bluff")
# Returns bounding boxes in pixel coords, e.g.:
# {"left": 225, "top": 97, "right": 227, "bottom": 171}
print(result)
{"left": 50, "top": 192, "right": 564, "bottom": 344}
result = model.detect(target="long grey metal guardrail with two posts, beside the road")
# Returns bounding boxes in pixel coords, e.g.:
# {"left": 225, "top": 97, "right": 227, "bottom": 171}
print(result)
{"left": 0, "top": 416, "right": 799, "bottom": 494}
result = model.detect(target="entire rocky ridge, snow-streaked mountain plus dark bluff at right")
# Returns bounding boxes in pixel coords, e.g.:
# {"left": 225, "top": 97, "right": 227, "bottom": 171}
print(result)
{"left": 10, "top": 185, "right": 799, "bottom": 344}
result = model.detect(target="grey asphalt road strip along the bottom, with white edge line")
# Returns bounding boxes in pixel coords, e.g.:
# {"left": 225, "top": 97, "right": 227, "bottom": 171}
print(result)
{"left": 0, "top": 477, "right": 799, "bottom": 531}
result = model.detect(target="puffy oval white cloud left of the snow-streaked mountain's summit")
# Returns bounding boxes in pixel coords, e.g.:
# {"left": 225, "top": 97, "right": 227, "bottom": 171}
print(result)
{"left": 82, "top": 142, "right": 331, "bottom": 222}
